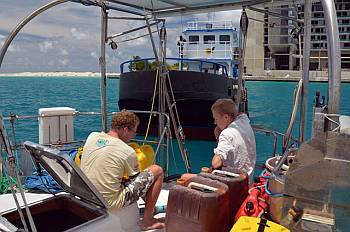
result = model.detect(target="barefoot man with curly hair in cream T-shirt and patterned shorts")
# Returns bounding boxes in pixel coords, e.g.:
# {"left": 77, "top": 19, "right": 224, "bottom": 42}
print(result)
{"left": 81, "top": 110, "right": 164, "bottom": 230}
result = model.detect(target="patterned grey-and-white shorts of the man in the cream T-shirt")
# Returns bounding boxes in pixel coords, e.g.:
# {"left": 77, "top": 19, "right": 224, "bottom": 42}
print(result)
{"left": 123, "top": 169, "right": 154, "bottom": 207}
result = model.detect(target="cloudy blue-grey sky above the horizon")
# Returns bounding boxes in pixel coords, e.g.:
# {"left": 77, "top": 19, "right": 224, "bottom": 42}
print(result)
{"left": 0, "top": 0, "right": 240, "bottom": 73}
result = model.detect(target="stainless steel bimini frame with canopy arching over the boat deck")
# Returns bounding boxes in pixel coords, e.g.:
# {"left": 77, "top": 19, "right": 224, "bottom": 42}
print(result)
{"left": 0, "top": 0, "right": 341, "bottom": 141}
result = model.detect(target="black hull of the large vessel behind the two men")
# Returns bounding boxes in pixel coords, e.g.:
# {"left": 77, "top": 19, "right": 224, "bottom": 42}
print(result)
{"left": 118, "top": 70, "right": 236, "bottom": 140}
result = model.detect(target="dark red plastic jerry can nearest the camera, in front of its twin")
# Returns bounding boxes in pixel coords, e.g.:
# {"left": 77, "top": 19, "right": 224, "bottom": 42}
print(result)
{"left": 166, "top": 176, "right": 230, "bottom": 232}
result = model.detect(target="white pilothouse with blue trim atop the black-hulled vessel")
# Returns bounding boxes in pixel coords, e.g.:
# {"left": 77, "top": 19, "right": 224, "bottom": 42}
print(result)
{"left": 177, "top": 21, "right": 239, "bottom": 79}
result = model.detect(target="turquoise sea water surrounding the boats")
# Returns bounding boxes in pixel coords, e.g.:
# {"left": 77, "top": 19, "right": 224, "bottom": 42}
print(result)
{"left": 0, "top": 77, "right": 350, "bottom": 172}
